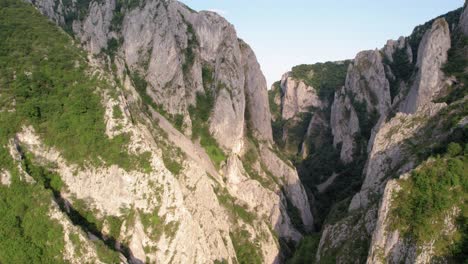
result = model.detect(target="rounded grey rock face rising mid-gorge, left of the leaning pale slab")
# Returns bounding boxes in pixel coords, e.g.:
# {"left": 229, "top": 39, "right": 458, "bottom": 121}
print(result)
{"left": 331, "top": 50, "right": 391, "bottom": 163}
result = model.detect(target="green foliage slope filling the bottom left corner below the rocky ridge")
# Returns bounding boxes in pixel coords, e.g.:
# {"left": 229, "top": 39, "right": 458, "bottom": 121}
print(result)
{"left": 0, "top": 168, "right": 65, "bottom": 263}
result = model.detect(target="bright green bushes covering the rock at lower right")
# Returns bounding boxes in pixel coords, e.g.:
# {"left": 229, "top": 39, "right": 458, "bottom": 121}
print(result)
{"left": 391, "top": 142, "right": 468, "bottom": 259}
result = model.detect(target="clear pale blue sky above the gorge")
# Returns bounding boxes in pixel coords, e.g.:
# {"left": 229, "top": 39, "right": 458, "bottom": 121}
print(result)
{"left": 182, "top": 0, "right": 464, "bottom": 86}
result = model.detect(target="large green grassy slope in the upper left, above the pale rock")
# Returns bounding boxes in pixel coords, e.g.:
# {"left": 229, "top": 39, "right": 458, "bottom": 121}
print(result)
{"left": 0, "top": 0, "right": 147, "bottom": 170}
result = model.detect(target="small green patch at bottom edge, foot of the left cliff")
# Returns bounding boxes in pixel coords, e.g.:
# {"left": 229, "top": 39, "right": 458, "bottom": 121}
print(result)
{"left": 229, "top": 229, "right": 263, "bottom": 264}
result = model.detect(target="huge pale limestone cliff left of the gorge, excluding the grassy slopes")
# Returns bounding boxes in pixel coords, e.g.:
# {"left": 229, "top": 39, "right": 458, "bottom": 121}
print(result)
{"left": 1, "top": 0, "right": 314, "bottom": 263}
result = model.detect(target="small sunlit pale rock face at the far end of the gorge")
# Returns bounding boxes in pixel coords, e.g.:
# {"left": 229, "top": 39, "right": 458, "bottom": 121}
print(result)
{"left": 281, "top": 73, "right": 323, "bottom": 120}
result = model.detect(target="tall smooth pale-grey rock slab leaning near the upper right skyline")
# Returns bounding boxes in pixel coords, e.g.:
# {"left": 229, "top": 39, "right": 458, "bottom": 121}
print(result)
{"left": 400, "top": 18, "right": 451, "bottom": 113}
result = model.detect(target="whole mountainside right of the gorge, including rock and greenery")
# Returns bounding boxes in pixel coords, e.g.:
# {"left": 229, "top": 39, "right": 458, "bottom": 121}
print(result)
{"left": 270, "top": 4, "right": 468, "bottom": 263}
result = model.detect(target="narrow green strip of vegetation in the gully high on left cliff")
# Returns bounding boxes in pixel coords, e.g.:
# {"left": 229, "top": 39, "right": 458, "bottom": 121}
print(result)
{"left": 189, "top": 91, "right": 226, "bottom": 168}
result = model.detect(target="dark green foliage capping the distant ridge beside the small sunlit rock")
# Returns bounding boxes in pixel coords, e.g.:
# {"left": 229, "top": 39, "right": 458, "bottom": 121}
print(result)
{"left": 291, "top": 61, "right": 350, "bottom": 99}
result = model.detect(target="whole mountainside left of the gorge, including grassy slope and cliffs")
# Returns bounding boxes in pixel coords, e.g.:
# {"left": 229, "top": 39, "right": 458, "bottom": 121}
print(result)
{"left": 0, "top": 0, "right": 313, "bottom": 263}
